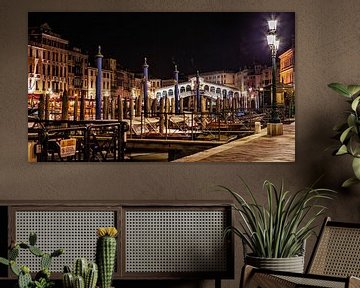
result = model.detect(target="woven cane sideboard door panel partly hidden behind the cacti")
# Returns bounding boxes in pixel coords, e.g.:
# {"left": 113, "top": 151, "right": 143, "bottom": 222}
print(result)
{"left": 16, "top": 211, "right": 115, "bottom": 272}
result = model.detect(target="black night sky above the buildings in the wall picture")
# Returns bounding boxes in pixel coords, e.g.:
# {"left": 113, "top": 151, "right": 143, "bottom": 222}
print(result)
{"left": 28, "top": 12, "right": 295, "bottom": 79}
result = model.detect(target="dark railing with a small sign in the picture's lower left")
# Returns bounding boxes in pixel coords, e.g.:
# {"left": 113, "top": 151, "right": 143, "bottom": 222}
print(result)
{"left": 28, "top": 119, "right": 129, "bottom": 162}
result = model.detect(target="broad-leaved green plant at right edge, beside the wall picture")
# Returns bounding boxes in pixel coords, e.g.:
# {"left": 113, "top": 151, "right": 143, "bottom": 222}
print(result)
{"left": 328, "top": 83, "right": 360, "bottom": 187}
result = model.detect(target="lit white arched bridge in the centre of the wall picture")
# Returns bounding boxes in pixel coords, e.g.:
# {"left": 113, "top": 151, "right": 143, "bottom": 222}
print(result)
{"left": 154, "top": 77, "right": 260, "bottom": 109}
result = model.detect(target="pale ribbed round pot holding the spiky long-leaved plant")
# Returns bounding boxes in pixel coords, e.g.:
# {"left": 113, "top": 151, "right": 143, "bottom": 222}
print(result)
{"left": 245, "top": 255, "right": 304, "bottom": 273}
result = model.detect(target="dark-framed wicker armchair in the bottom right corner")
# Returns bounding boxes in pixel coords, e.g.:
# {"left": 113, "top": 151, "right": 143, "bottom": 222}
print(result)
{"left": 240, "top": 218, "right": 360, "bottom": 288}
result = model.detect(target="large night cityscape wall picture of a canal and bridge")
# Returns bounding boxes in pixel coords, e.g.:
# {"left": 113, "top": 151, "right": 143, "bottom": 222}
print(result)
{"left": 27, "top": 12, "right": 296, "bottom": 162}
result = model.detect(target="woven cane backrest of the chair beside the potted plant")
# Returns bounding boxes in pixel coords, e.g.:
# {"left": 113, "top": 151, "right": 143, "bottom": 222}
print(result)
{"left": 307, "top": 218, "right": 360, "bottom": 277}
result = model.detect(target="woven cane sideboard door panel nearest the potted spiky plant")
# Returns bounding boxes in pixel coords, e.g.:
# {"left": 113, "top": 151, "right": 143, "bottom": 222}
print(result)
{"left": 125, "top": 210, "right": 226, "bottom": 273}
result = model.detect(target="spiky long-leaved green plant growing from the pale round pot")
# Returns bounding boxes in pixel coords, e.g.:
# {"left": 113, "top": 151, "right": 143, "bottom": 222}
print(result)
{"left": 221, "top": 180, "right": 334, "bottom": 258}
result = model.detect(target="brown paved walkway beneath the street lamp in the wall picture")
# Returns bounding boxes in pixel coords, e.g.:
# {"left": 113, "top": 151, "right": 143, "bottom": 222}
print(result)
{"left": 174, "top": 122, "right": 295, "bottom": 162}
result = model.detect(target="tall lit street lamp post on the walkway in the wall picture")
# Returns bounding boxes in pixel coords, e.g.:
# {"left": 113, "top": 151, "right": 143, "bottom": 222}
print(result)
{"left": 267, "top": 20, "right": 280, "bottom": 123}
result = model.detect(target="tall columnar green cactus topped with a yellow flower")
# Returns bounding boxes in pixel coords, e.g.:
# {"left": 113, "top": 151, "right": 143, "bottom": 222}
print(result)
{"left": 96, "top": 227, "right": 117, "bottom": 288}
